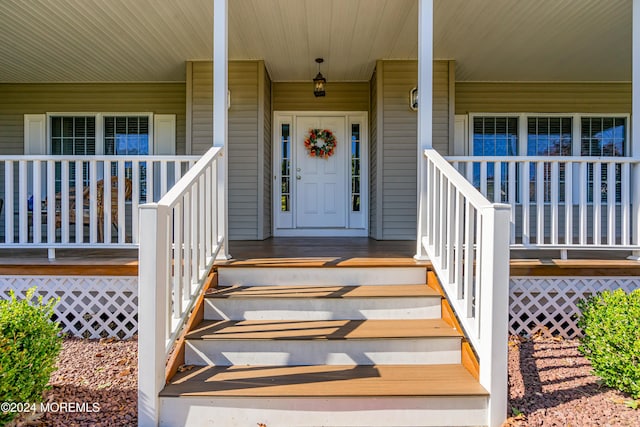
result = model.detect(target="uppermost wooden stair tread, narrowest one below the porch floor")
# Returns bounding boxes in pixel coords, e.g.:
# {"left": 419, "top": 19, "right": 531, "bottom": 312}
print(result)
{"left": 206, "top": 285, "right": 440, "bottom": 298}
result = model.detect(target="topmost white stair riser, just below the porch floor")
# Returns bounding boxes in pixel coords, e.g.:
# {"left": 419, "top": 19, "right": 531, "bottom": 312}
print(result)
{"left": 218, "top": 267, "right": 427, "bottom": 286}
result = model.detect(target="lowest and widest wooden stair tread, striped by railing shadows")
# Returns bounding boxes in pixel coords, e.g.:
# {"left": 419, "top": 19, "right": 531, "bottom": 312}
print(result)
{"left": 160, "top": 364, "right": 488, "bottom": 397}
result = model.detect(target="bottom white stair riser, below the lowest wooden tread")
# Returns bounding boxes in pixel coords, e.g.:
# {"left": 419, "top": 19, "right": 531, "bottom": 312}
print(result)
{"left": 160, "top": 396, "right": 487, "bottom": 427}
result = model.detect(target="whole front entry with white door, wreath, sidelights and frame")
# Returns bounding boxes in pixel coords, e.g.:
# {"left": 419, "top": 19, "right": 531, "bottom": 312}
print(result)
{"left": 273, "top": 113, "right": 367, "bottom": 236}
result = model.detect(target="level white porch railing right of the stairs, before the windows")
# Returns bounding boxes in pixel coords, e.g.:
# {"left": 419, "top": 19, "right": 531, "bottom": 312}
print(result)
{"left": 447, "top": 157, "right": 640, "bottom": 255}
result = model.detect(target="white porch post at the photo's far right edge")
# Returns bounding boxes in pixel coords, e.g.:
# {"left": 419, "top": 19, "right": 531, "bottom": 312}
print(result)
{"left": 629, "top": 0, "right": 640, "bottom": 260}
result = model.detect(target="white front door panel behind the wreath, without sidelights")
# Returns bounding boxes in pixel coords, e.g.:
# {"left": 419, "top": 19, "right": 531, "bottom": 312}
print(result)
{"left": 294, "top": 117, "right": 348, "bottom": 228}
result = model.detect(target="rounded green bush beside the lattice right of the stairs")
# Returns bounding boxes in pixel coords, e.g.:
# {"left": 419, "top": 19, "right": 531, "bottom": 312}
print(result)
{"left": 578, "top": 289, "right": 640, "bottom": 399}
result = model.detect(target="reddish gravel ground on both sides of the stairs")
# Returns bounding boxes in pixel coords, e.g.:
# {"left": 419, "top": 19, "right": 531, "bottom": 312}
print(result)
{"left": 11, "top": 338, "right": 640, "bottom": 427}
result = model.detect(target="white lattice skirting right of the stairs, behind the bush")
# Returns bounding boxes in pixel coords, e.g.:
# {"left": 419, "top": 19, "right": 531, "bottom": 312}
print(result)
{"left": 509, "top": 276, "right": 640, "bottom": 338}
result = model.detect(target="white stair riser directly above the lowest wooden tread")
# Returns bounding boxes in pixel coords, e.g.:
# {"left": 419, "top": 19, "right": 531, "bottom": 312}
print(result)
{"left": 185, "top": 337, "right": 461, "bottom": 366}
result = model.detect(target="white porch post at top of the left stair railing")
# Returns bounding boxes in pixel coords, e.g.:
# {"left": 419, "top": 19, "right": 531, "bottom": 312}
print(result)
{"left": 213, "top": 0, "right": 230, "bottom": 259}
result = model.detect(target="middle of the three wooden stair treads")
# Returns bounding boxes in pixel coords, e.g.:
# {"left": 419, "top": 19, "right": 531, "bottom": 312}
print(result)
{"left": 187, "top": 319, "right": 461, "bottom": 340}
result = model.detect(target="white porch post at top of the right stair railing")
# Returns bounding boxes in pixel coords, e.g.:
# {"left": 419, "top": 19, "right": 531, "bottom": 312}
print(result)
{"left": 415, "top": 0, "right": 433, "bottom": 260}
